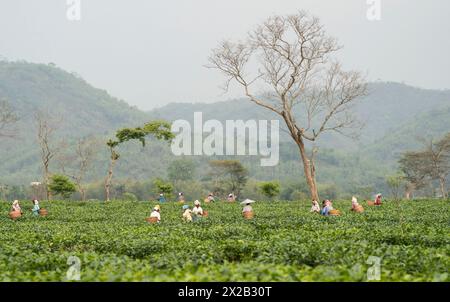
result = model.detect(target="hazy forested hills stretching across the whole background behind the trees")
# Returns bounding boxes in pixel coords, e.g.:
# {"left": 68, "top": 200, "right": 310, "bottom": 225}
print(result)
{"left": 0, "top": 61, "right": 450, "bottom": 200}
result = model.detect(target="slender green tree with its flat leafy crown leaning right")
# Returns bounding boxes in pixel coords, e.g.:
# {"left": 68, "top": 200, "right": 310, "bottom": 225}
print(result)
{"left": 105, "top": 121, "right": 175, "bottom": 201}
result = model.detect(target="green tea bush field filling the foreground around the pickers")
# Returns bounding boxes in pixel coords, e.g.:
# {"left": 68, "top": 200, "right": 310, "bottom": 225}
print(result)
{"left": 0, "top": 200, "right": 450, "bottom": 281}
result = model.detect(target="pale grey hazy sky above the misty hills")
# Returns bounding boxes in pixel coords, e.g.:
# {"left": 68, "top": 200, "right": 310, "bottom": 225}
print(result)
{"left": 0, "top": 0, "right": 450, "bottom": 109}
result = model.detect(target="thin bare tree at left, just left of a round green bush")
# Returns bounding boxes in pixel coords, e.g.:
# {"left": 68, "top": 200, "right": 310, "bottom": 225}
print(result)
{"left": 35, "top": 111, "right": 65, "bottom": 200}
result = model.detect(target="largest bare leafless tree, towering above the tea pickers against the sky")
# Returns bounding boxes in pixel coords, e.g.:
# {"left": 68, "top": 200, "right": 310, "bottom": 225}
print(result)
{"left": 208, "top": 11, "right": 367, "bottom": 200}
